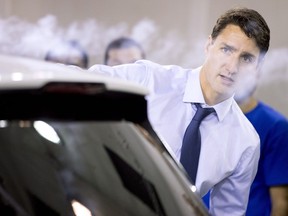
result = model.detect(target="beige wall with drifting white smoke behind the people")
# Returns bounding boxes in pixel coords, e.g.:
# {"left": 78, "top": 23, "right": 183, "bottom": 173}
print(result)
{"left": 0, "top": 0, "right": 288, "bottom": 116}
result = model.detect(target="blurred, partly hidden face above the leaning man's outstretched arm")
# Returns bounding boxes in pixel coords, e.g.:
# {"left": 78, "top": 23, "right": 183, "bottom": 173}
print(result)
{"left": 107, "top": 47, "right": 142, "bottom": 66}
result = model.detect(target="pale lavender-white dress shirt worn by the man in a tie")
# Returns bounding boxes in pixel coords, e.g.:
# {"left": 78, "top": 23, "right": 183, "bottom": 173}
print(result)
{"left": 89, "top": 60, "right": 260, "bottom": 216}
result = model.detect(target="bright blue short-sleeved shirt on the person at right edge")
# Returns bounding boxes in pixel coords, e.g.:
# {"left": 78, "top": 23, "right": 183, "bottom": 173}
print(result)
{"left": 203, "top": 102, "right": 288, "bottom": 216}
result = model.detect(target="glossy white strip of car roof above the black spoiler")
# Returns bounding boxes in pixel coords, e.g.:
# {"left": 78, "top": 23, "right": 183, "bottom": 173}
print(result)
{"left": 0, "top": 54, "right": 149, "bottom": 95}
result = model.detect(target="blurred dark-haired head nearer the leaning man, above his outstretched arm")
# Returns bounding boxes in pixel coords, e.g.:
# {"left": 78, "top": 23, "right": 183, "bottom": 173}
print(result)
{"left": 104, "top": 37, "right": 145, "bottom": 66}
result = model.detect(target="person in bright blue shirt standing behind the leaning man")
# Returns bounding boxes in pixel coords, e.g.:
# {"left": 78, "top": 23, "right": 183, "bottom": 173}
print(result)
{"left": 203, "top": 44, "right": 288, "bottom": 216}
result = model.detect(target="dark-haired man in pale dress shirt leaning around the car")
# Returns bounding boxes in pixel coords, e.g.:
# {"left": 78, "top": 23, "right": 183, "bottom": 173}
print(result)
{"left": 89, "top": 8, "right": 270, "bottom": 216}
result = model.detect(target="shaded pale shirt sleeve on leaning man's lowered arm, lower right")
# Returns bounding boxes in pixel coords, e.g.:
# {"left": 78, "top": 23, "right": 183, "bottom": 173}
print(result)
{"left": 209, "top": 144, "right": 260, "bottom": 216}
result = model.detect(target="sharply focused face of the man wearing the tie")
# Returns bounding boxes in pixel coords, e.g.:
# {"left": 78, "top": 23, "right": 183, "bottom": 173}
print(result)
{"left": 201, "top": 25, "right": 260, "bottom": 102}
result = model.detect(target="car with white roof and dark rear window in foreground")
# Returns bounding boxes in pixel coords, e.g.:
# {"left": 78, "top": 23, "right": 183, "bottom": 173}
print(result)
{"left": 0, "top": 55, "right": 208, "bottom": 216}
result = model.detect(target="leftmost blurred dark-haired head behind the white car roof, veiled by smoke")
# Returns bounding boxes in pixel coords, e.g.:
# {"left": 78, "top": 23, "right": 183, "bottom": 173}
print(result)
{"left": 44, "top": 40, "right": 89, "bottom": 69}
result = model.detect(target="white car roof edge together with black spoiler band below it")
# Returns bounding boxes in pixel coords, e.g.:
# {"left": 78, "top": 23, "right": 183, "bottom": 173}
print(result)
{"left": 0, "top": 55, "right": 148, "bottom": 122}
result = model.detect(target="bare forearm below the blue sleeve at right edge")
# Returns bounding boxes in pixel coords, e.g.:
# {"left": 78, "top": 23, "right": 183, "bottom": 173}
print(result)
{"left": 269, "top": 185, "right": 288, "bottom": 216}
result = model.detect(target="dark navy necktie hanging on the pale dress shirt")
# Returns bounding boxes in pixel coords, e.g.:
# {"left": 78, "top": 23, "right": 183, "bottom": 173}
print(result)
{"left": 180, "top": 103, "right": 215, "bottom": 184}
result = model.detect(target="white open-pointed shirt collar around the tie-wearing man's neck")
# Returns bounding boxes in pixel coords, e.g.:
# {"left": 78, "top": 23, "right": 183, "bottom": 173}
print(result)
{"left": 183, "top": 66, "right": 234, "bottom": 121}
